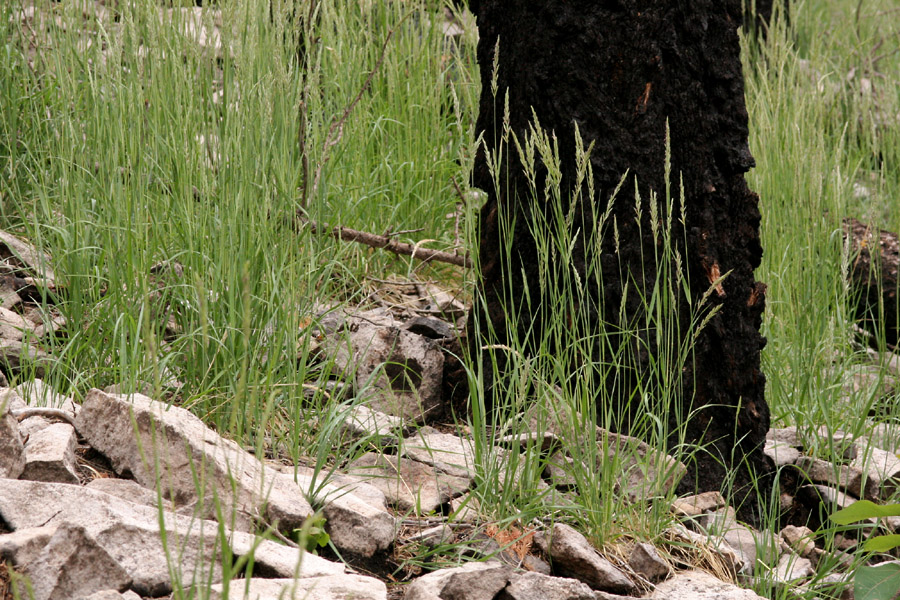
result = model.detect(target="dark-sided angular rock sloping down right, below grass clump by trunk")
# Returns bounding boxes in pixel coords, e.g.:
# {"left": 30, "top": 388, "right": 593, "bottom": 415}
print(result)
{"left": 535, "top": 523, "right": 637, "bottom": 593}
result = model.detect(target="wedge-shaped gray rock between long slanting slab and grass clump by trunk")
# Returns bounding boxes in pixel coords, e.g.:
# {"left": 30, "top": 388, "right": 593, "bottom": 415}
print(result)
{"left": 349, "top": 452, "right": 471, "bottom": 515}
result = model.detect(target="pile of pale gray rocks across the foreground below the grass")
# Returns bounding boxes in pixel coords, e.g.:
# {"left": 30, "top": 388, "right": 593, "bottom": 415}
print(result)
{"left": 0, "top": 366, "right": 900, "bottom": 600}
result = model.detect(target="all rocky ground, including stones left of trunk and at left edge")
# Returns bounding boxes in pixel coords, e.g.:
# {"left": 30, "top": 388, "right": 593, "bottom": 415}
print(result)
{"left": 0, "top": 225, "right": 900, "bottom": 600}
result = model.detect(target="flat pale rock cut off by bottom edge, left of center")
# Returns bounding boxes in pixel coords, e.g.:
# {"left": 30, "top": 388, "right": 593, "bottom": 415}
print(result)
{"left": 209, "top": 574, "right": 387, "bottom": 600}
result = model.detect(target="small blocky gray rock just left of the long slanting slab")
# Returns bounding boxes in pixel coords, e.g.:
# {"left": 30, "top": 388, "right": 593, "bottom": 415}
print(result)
{"left": 20, "top": 423, "right": 79, "bottom": 483}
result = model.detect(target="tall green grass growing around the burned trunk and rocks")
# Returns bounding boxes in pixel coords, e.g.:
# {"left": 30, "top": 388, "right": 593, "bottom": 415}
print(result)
{"left": 0, "top": 0, "right": 900, "bottom": 596}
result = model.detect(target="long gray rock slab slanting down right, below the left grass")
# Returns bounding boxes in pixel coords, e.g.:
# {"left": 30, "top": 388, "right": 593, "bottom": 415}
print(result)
{"left": 77, "top": 390, "right": 313, "bottom": 531}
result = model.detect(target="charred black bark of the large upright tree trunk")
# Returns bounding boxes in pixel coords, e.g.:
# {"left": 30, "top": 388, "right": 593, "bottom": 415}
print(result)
{"left": 469, "top": 0, "right": 771, "bottom": 520}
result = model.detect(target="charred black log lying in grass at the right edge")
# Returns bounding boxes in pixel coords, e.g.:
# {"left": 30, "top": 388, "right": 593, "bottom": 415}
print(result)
{"left": 844, "top": 217, "right": 900, "bottom": 349}
